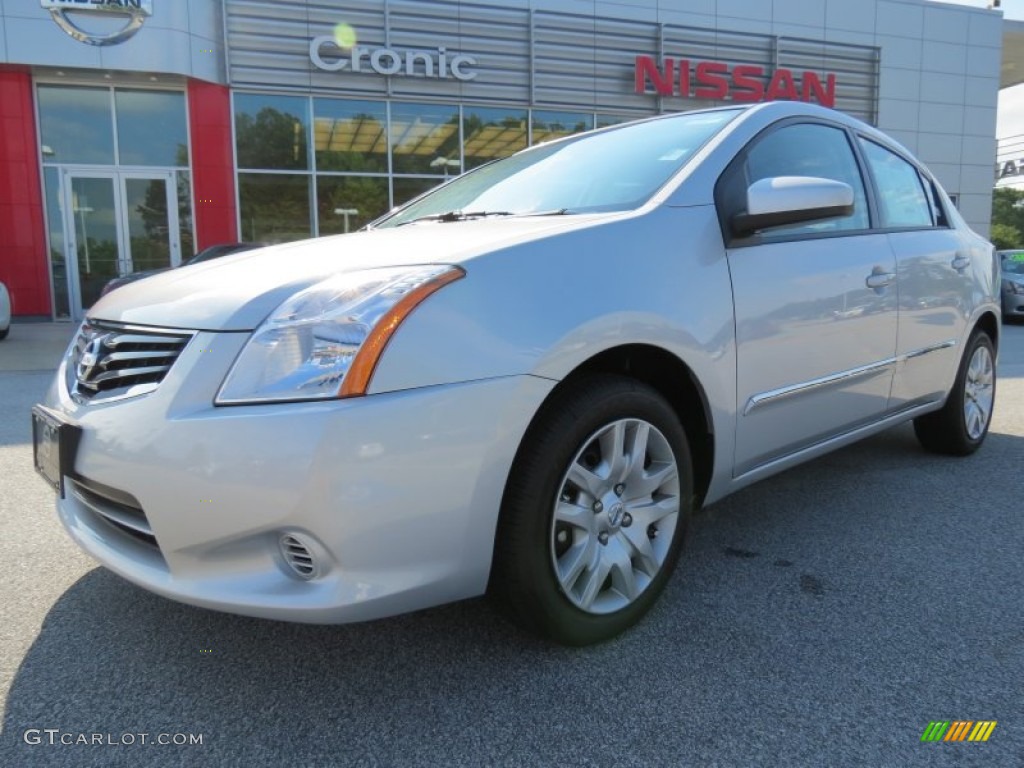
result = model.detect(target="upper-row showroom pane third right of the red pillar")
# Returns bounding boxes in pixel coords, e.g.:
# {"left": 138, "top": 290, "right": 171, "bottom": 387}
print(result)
{"left": 390, "top": 103, "right": 462, "bottom": 175}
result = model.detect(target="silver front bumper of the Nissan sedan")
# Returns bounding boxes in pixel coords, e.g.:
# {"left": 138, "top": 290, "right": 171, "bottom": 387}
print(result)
{"left": 46, "top": 333, "right": 555, "bottom": 623}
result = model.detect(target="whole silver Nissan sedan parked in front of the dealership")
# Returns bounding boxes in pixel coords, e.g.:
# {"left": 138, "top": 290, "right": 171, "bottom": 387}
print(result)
{"left": 34, "top": 102, "right": 1000, "bottom": 644}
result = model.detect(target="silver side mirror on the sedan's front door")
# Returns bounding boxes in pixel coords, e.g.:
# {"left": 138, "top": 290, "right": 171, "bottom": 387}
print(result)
{"left": 730, "top": 176, "right": 853, "bottom": 238}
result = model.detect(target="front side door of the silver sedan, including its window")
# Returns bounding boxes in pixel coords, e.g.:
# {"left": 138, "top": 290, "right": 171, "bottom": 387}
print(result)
{"left": 716, "top": 121, "right": 896, "bottom": 475}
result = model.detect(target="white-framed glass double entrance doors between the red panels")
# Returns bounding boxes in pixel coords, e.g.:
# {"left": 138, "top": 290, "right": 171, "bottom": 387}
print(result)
{"left": 62, "top": 170, "right": 181, "bottom": 319}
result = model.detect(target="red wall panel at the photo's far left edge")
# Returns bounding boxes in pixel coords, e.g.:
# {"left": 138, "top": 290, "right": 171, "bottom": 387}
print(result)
{"left": 0, "top": 67, "right": 50, "bottom": 315}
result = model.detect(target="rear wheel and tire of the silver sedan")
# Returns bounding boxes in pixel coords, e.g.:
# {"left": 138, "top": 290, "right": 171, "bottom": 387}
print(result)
{"left": 913, "top": 331, "right": 995, "bottom": 456}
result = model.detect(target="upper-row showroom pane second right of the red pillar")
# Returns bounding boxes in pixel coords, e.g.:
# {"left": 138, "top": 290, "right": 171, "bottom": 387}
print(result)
{"left": 313, "top": 98, "right": 387, "bottom": 173}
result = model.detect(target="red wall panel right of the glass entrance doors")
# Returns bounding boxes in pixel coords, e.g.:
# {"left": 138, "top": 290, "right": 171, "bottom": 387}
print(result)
{"left": 188, "top": 80, "right": 239, "bottom": 250}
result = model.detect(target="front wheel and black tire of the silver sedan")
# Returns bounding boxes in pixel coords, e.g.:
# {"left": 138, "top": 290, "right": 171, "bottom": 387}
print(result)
{"left": 490, "top": 375, "right": 693, "bottom": 645}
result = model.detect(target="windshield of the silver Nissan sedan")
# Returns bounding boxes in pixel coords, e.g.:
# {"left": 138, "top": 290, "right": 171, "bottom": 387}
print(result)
{"left": 374, "top": 110, "right": 739, "bottom": 227}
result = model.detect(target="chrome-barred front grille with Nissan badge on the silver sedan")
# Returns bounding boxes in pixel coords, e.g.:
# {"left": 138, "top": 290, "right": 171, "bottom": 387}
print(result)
{"left": 67, "top": 322, "right": 193, "bottom": 403}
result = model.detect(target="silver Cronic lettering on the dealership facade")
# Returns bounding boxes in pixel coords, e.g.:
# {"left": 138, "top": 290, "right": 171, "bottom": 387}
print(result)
{"left": 309, "top": 35, "right": 476, "bottom": 81}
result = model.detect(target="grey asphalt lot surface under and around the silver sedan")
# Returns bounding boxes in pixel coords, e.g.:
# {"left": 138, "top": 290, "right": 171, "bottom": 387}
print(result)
{"left": 0, "top": 326, "right": 1024, "bottom": 768}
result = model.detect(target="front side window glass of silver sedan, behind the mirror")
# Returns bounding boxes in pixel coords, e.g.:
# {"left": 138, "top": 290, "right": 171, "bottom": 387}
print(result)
{"left": 746, "top": 123, "right": 869, "bottom": 238}
